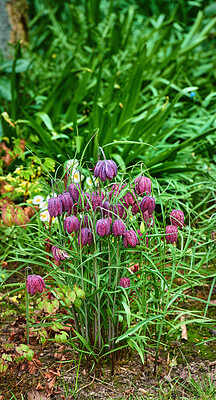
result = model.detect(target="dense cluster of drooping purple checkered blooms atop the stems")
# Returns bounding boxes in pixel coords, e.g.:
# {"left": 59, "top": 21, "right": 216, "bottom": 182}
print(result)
{"left": 48, "top": 159, "right": 155, "bottom": 253}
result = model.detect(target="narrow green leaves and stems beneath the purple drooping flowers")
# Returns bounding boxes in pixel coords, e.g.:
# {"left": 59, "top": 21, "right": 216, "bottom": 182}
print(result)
{"left": 4, "top": 159, "right": 215, "bottom": 363}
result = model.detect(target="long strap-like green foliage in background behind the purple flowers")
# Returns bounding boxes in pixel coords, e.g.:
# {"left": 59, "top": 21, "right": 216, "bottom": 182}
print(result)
{"left": 2, "top": 1, "right": 215, "bottom": 184}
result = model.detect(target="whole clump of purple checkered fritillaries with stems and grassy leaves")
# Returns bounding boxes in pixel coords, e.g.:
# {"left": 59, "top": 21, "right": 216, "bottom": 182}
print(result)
{"left": 24, "top": 148, "right": 193, "bottom": 367}
